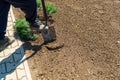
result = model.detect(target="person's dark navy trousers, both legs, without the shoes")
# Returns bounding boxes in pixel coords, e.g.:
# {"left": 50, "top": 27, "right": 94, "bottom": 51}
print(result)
{"left": 0, "top": 0, "right": 37, "bottom": 39}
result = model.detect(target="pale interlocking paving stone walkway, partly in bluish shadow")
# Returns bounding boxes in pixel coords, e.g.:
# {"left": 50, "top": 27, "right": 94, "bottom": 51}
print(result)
{"left": 0, "top": 9, "right": 32, "bottom": 80}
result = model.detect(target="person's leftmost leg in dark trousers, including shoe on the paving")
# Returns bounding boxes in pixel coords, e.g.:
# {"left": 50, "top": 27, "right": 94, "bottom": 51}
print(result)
{"left": 0, "top": 0, "right": 15, "bottom": 52}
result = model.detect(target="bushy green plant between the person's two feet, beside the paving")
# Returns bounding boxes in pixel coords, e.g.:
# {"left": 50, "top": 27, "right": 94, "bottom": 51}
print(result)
{"left": 14, "top": 19, "right": 37, "bottom": 40}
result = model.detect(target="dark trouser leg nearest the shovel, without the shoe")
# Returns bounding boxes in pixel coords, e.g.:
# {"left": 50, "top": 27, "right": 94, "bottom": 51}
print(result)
{"left": 8, "top": 0, "right": 37, "bottom": 23}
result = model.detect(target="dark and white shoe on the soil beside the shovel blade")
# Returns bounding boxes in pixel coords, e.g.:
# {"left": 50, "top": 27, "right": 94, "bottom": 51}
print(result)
{"left": 30, "top": 19, "right": 48, "bottom": 31}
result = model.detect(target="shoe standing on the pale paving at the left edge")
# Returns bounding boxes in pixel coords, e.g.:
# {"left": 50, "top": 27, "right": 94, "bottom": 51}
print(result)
{"left": 0, "top": 37, "right": 15, "bottom": 52}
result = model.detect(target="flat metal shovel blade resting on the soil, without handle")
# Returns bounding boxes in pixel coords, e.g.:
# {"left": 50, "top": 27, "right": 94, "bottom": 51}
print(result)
{"left": 42, "top": 26, "right": 56, "bottom": 43}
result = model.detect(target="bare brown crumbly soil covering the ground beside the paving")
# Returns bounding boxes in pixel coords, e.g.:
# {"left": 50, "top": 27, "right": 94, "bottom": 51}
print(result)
{"left": 14, "top": 0, "right": 120, "bottom": 80}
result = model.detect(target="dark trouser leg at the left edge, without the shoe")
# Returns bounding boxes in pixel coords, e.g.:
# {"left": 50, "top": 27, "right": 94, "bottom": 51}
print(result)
{"left": 0, "top": 0, "right": 10, "bottom": 40}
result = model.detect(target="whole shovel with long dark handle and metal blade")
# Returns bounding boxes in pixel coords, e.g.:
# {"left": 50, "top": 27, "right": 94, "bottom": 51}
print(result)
{"left": 41, "top": 0, "right": 56, "bottom": 43}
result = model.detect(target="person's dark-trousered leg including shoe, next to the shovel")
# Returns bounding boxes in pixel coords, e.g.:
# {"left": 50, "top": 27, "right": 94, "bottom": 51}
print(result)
{"left": 7, "top": 0, "right": 48, "bottom": 30}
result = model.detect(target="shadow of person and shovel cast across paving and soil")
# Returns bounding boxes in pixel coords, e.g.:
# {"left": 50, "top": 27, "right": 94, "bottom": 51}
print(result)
{"left": 0, "top": 42, "right": 43, "bottom": 80}
